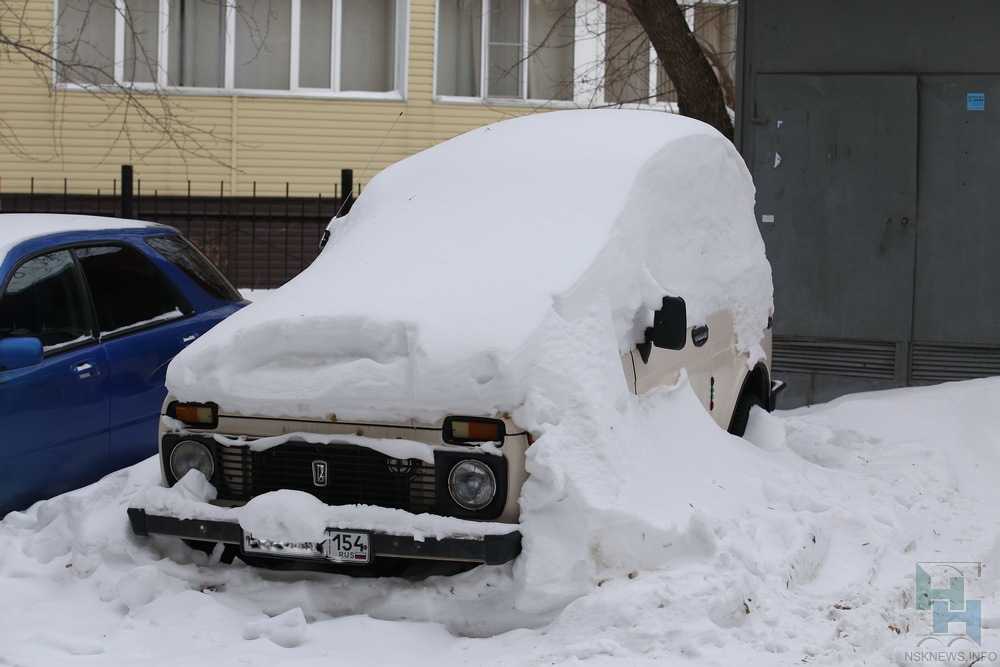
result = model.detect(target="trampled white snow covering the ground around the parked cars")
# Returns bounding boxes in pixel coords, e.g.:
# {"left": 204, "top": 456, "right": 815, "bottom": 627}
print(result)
{"left": 0, "top": 379, "right": 1000, "bottom": 666}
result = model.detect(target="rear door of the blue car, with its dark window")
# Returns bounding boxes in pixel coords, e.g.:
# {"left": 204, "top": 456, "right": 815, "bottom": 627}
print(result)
{"left": 75, "top": 243, "right": 206, "bottom": 467}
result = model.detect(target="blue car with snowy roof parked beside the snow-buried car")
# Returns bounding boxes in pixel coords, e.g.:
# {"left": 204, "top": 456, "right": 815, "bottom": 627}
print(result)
{"left": 0, "top": 214, "right": 246, "bottom": 518}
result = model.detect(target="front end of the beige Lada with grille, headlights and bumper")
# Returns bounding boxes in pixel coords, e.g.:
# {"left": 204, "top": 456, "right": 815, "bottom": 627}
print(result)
{"left": 128, "top": 398, "right": 530, "bottom": 573}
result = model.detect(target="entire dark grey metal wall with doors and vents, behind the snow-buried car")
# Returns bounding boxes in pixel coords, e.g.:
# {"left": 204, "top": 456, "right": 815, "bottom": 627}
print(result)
{"left": 737, "top": 0, "right": 1000, "bottom": 406}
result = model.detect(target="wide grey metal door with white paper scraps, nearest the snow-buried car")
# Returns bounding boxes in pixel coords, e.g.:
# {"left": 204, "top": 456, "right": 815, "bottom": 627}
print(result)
{"left": 751, "top": 74, "right": 918, "bottom": 405}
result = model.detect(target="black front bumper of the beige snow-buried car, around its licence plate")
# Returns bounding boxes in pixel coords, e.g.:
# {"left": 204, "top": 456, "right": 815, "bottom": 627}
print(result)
{"left": 128, "top": 507, "right": 521, "bottom": 569}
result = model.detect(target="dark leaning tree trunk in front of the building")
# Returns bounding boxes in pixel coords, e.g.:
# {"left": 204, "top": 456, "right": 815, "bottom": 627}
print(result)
{"left": 628, "top": 0, "right": 733, "bottom": 140}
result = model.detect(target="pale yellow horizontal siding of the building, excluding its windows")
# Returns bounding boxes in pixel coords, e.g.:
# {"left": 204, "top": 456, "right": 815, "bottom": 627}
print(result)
{"left": 0, "top": 0, "right": 530, "bottom": 195}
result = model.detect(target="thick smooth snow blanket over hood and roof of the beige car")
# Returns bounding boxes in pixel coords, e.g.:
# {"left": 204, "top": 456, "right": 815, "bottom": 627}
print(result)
{"left": 168, "top": 110, "right": 771, "bottom": 418}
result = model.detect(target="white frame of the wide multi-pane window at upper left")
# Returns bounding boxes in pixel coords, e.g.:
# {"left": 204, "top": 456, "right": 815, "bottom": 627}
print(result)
{"left": 52, "top": 0, "right": 410, "bottom": 101}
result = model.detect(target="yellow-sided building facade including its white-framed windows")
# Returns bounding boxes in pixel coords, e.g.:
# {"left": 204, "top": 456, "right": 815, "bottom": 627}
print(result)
{"left": 0, "top": 0, "right": 735, "bottom": 196}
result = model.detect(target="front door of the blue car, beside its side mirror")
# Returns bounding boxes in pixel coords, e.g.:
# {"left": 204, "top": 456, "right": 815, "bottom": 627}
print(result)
{"left": 0, "top": 250, "right": 109, "bottom": 516}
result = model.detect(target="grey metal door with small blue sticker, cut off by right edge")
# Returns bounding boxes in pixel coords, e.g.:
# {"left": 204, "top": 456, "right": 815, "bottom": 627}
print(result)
{"left": 910, "top": 76, "right": 1000, "bottom": 383}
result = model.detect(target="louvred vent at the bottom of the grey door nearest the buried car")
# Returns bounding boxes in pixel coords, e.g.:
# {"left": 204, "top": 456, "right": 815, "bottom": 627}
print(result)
{"left": 773, "top": 336, "right": 896, "bottom": 380}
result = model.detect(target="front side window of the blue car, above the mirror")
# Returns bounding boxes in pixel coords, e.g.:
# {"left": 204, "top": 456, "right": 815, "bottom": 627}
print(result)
{"left": 0, "top": 250, "right": 92, "bottom": 353}
